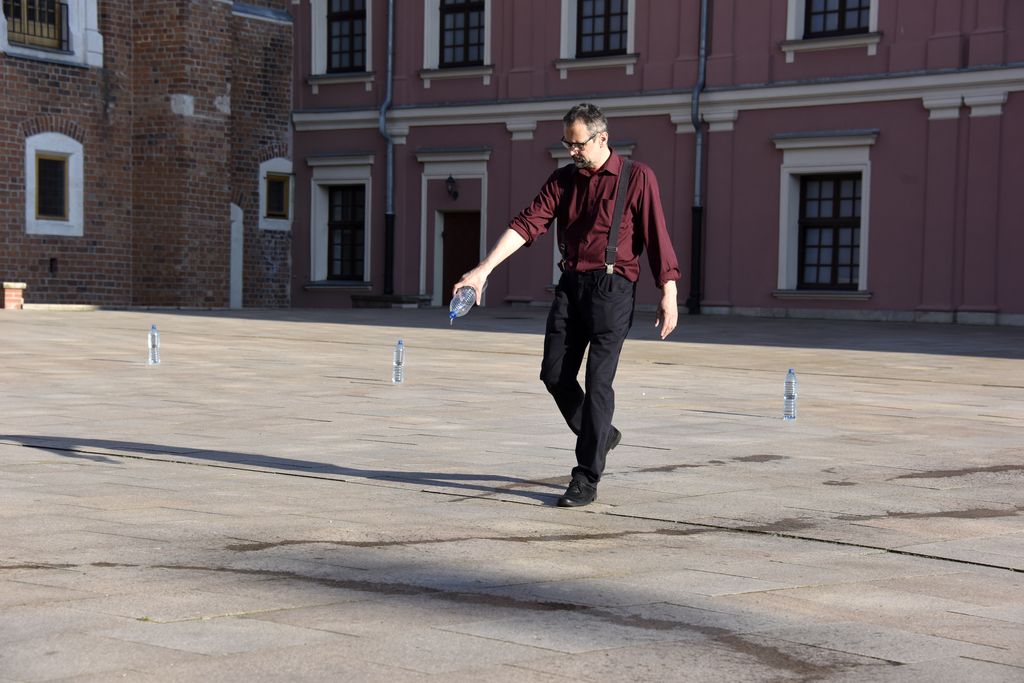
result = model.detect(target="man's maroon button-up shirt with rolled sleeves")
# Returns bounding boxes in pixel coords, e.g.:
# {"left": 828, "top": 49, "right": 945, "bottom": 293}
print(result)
{"left": 509, "top": 152, "right": 680, "bottom": 287}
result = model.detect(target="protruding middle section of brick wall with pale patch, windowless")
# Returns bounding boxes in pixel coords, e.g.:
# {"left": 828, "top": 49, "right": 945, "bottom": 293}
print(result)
{"left": 133, "top": 0, "right": 230, "bottom": 306}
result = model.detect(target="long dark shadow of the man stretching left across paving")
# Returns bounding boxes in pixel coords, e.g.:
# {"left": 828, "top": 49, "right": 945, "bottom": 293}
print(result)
{"left": 0, "top": 434, "right": 564, "bottom": 504}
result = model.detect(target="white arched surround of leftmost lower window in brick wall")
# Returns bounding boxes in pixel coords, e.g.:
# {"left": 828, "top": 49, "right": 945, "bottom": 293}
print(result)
{"left": 25, "top": 133, "right": 85, "bottom": 238}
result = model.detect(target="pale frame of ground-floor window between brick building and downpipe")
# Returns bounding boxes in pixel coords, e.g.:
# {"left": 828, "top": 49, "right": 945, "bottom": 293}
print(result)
{"left": 306, "top": 155, "right": 374, "bottom": 284}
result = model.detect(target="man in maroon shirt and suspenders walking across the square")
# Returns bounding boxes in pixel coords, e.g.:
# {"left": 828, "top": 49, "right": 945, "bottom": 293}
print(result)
{"left": 453, "top": 103, "right": 680, "bottom": 507}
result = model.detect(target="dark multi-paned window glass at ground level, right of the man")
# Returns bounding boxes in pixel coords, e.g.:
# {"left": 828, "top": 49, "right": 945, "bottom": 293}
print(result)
{"left": 797, "top": 174, "right": 861, "bottom": 290}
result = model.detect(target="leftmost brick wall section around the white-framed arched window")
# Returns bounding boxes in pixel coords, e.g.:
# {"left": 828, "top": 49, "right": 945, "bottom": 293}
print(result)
{"left": 0, "top": 0, "right": 131, "bottom": 305}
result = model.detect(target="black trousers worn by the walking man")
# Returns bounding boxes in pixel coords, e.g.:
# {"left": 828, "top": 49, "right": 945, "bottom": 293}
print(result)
{"left": 541, "top": 270, "right": 636, "bottom": 483}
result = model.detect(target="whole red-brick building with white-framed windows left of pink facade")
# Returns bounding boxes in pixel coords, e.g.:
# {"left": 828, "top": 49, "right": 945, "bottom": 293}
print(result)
{"left": 0, "top": 0, "right": 293, "bottom": 307}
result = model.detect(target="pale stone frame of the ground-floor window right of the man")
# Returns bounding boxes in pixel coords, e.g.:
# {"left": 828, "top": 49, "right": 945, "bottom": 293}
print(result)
{"left": 774, "top": 131, "right": 878, "bottom": 296}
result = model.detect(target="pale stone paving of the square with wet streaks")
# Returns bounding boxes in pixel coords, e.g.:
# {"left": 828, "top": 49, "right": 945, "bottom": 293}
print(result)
{"left": 0, "top": 307, "right": 1024, "bottom": 683}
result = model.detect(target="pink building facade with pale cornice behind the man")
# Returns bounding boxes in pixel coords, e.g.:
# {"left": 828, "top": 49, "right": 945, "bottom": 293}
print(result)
{"left": 291, "top": 0, "right": 1024, "bottom": 325}
